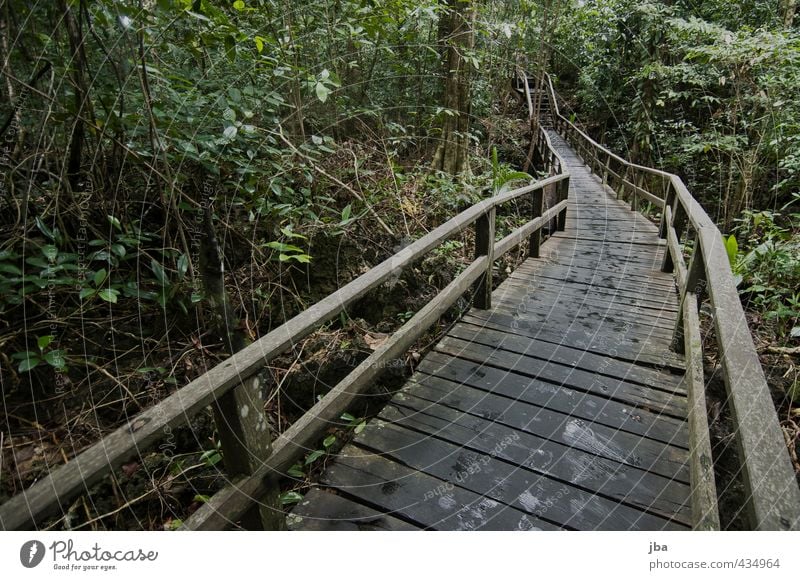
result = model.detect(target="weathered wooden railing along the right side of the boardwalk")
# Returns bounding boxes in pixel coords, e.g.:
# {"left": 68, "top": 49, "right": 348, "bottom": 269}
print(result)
{"left": 546, "top": 76, "right": 800, "bottom": 530}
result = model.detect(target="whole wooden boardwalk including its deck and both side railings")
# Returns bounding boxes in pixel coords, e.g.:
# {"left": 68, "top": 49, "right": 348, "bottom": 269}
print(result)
{"left": 0, "top": 77, "right": 800, "bottom": 530}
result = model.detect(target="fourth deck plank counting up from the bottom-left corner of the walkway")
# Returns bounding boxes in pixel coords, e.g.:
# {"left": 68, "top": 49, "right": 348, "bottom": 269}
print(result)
{"left": 380, "top": 396, "right": 691, "bottom": 523}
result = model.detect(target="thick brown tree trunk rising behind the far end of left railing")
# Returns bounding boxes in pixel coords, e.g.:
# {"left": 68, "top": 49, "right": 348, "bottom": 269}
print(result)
{"left": 432, "top": 0, "right": 475, "bottom": 175}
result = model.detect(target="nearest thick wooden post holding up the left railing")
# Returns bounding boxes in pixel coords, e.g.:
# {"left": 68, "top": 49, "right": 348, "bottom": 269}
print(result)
{"left": 214, "top": 375, "right": 285, "bottom": 530}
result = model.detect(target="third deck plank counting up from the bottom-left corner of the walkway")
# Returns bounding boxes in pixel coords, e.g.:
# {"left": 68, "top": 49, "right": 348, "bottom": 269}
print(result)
{"left": 355, "top": 419, "right": 686, "bottom": 530}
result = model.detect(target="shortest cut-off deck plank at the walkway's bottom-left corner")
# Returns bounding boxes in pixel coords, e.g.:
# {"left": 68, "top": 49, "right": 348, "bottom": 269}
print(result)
{"left": 286, "top": 488, "right": 421, "bottom": 532}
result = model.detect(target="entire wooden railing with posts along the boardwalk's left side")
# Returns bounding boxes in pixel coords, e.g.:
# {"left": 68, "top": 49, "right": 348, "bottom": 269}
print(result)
{"left": 0, "top": 125, "right": 569, "bottom": 530}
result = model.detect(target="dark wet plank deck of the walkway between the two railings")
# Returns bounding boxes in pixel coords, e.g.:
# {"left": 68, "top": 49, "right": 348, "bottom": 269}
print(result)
{"left": 288, "top": 131, "right": 691, "bottom": 530}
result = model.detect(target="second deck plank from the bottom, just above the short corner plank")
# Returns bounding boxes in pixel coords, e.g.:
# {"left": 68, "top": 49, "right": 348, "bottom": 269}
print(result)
{"left": 323, "top": 445, "right": 558, "bottom": 530}
